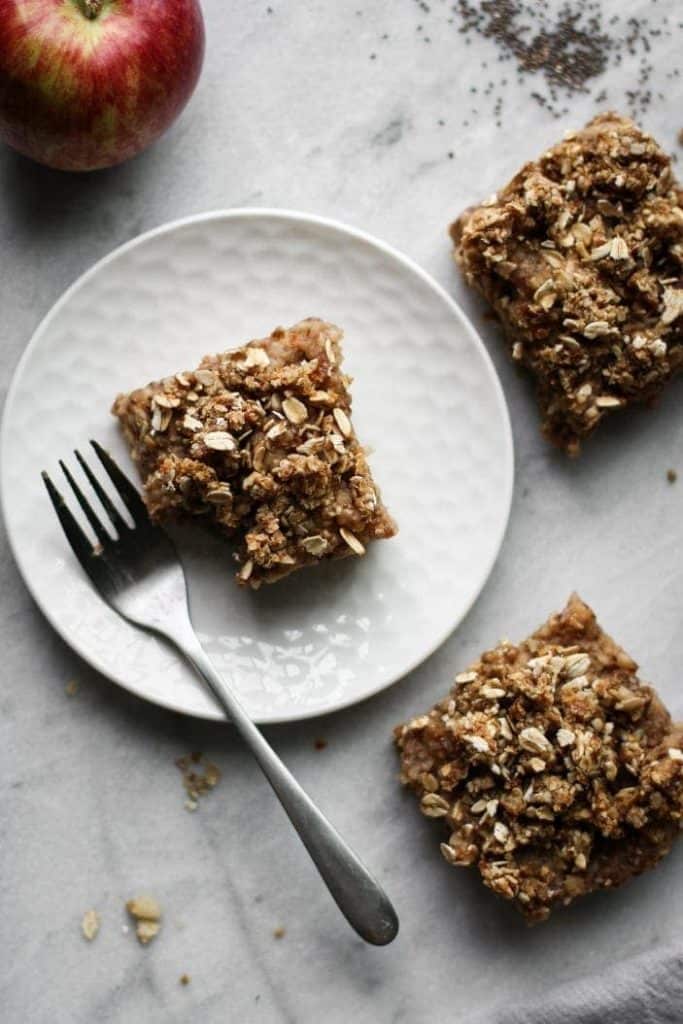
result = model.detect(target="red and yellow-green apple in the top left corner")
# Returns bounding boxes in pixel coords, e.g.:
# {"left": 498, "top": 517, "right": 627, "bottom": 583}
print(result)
{"left": 0, "top": 0, "right": 204, "bottom": 171}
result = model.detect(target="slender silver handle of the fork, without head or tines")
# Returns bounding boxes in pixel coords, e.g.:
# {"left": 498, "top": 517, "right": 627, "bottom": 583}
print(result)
{"left": 172, "top": 631, "right": 398, "bottom": 946}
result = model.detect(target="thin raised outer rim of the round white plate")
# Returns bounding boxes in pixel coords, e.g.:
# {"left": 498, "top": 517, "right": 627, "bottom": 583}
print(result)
{"left": 0, "top": 207, "right": 514, "bottom": 725}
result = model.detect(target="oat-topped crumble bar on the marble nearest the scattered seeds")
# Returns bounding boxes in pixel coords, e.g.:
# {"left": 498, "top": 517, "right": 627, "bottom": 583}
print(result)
{"left": 451, "top": 114, "right": 683, "bottom": 455}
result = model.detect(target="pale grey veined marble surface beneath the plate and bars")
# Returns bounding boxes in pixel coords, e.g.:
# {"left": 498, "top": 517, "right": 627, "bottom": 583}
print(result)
{"left": 0, "top": 0, "right": 683, "bottom": 1024}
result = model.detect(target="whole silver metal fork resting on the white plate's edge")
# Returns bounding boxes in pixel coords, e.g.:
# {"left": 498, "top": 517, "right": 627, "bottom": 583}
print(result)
{"left": 42, "top": 441, "right": 398, "bottom": 945}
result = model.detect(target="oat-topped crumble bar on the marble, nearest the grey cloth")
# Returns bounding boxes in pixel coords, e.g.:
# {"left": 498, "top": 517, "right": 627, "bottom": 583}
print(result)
{"left": 395, "top": 595, "right": 683, "bottom": 922}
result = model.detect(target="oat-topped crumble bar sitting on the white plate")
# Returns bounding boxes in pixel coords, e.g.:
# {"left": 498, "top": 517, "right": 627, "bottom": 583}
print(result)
{"left": 113, "top": 319, "right": 396, "bottom": 588}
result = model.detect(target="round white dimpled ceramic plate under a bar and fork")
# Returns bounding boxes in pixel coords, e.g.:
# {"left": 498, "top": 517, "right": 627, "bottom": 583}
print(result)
{"left": 2, "top": 210, "right": 513, "bottom": 722}
